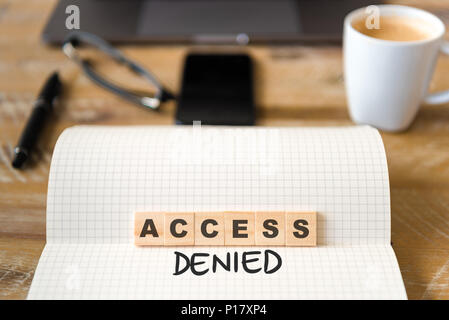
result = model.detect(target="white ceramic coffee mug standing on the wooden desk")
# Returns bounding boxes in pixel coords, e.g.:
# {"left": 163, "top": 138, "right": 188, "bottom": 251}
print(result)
{"left": 343, "top": 5, "right": 449, "bottom": 131}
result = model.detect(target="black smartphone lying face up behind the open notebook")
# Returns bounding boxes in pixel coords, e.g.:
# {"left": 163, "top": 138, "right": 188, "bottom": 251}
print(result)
{"left": 176, "top": 54, "right": 255, "bottom": 125}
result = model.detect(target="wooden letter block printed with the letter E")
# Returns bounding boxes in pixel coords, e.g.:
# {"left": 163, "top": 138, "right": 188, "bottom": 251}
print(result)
{"left": 224, "top": 211, "right": 255, "bottom": 246}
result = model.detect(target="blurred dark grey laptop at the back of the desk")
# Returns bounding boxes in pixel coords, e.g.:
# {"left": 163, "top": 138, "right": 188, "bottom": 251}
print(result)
{"left": 42, "top": 0, "right": 370, "bottom": 45}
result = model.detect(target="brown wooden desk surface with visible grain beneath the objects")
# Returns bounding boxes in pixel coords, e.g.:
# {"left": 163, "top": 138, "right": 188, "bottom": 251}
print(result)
{"left": 0, "top": 0, "right": 449, "bottom": 299}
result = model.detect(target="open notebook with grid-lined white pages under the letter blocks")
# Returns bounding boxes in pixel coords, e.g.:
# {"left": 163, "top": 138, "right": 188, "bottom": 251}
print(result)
{"left": 28, "top": 125, "right": 406, "bottom": 299}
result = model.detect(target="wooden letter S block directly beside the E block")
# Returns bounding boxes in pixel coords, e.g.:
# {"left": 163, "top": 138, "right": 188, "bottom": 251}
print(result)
{"left": 255, "top": 211, "right": 285, "bottom": 246}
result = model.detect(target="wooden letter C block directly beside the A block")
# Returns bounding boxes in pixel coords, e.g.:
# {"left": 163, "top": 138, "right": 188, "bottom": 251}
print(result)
{"left": 164, "top": 212, "right": 195, "bottom": 246}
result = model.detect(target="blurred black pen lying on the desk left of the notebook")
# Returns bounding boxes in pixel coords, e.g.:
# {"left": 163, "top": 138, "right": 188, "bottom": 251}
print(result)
{"left": 12, "top": 72, "right": 62, "bottom": 168}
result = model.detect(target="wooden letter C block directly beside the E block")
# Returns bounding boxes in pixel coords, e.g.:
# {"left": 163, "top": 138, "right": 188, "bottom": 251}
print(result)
{"left": 195, "top": 212, "right": 224, "bottom": 246}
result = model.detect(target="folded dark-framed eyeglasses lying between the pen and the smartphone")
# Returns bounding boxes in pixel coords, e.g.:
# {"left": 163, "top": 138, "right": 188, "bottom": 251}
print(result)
{"left": 62, "top": 31, "right": 175, "bottom": 110}
